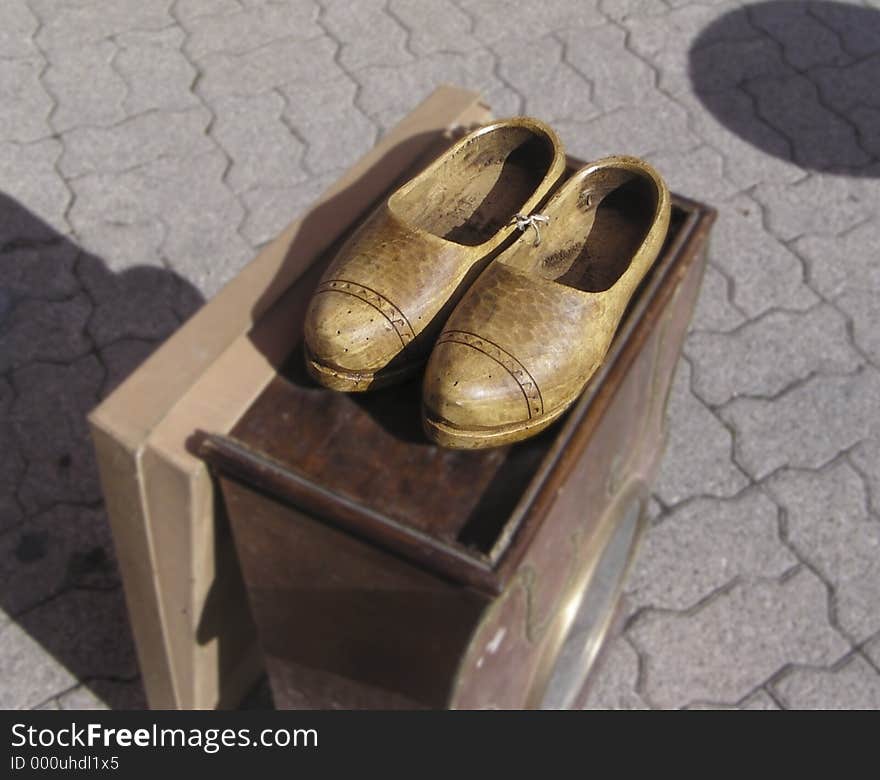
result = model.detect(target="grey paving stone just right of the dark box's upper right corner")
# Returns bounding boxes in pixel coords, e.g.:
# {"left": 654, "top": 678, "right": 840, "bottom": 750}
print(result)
{"left": 709, "top": 195, "right": 819, "bottom": 317}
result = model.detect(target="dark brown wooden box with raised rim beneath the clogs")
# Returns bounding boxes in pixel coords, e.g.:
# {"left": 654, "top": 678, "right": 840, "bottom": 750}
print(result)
{"left": 200, "top": 141, "right": 715, "bottom": 709}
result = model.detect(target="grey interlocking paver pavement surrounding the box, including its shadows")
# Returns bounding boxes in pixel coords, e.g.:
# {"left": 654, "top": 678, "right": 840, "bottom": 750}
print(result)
{"left": 0, "top": 0, "right": 880, "bottom": 709}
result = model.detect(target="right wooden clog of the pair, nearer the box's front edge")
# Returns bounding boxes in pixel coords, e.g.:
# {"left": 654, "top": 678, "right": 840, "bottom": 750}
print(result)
{"left": 423, "top": 157, "right": 670, "bottom": 448}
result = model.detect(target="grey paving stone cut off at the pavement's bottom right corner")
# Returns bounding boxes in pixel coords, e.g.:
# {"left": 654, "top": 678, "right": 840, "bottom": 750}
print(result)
{"left": 773, "top": 655, "right": 880, "bottom": 710}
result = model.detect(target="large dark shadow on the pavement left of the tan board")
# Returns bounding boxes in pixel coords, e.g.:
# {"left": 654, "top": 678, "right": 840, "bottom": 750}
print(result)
{"left": 0, "top": 193, "right": 202, "bottom": 709}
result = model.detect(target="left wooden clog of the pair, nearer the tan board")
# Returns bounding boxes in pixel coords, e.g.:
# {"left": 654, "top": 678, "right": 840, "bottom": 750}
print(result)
{"left": 305, "top": 117, "right": 565, "bottom": 391}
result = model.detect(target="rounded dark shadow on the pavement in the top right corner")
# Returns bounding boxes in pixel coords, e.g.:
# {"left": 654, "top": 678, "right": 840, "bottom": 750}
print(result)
{"left": 689, "top": 0, "right": 880, "bottom": 177}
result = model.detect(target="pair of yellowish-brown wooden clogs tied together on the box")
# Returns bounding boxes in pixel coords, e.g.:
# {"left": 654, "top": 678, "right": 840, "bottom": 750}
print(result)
{"left": 305, "top": 117, "right": 670, "bottom": 448}
